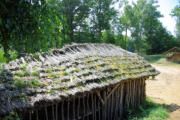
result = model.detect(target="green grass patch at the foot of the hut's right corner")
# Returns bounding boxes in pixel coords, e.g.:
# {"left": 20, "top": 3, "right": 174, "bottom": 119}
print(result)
{"left": 128, "top": 98, "right": 169, "bottom": 120}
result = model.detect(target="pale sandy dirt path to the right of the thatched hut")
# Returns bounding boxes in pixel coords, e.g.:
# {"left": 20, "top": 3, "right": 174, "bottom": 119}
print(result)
{"left": 146, "top": 65, "right": 180, "bottom": 120}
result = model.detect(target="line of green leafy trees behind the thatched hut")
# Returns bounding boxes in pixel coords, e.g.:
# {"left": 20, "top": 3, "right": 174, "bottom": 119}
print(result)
{"left": 0, "top": 0, "right": 180, "bottom": 59}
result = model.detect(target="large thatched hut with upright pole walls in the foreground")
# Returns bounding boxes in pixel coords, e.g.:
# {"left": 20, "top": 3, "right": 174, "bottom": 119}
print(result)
{"left": 0, "top": 44, "right": 159, "bottom": 120}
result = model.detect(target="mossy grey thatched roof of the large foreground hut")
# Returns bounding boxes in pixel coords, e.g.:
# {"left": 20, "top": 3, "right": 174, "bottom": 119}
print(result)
{"left": 0, "top": 44, "right": 158, "bottom": 116}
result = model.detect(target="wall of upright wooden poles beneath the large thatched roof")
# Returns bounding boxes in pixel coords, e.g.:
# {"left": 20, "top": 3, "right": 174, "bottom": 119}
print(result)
{"left": 15, "top": 78, "right": 146, "bottom": 120}
